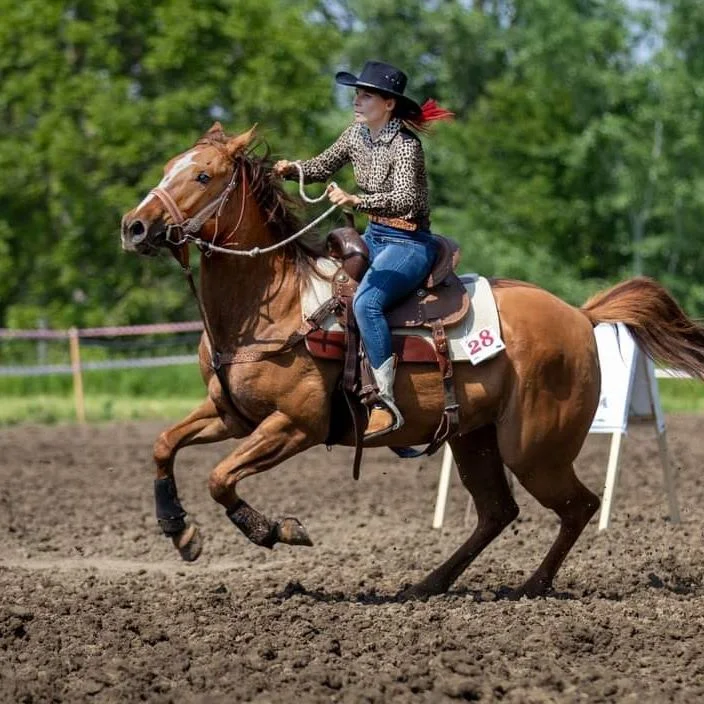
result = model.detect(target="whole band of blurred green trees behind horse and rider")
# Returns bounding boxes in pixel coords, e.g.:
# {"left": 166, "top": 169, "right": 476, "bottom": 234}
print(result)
{"left": 0, "top": 0, "right": 704, "bottom": 327}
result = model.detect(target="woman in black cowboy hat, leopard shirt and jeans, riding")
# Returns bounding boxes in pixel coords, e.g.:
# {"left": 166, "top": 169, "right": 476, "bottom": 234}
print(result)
{"left": 274, "top": 61, "right": 452, "bottom": 440}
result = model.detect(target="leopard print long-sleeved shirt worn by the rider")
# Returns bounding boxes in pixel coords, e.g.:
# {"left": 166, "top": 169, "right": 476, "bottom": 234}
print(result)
{"left": 292, "top": 118, "right": 430, "bottom": 230}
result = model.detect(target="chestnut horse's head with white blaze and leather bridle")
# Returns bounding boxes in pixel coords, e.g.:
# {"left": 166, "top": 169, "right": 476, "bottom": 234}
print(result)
{"left": 121, "top": 122, "right": 254, "bottom": 256}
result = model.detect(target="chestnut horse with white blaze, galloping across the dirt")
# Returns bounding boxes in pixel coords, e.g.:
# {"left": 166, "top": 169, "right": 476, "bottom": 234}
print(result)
{"left": 121, "top": 123, "right": 704, "bottom": 598}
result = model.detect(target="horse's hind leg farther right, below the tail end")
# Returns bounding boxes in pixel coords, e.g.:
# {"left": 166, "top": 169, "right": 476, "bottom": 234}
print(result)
{"left": 513, "top": 463, "right": 600, "bottom": 598}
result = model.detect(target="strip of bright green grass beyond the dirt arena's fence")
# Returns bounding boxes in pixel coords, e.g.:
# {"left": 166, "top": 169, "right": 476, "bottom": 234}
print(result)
{"left": 0, "top": 365, "right": 704, "bottom": 425}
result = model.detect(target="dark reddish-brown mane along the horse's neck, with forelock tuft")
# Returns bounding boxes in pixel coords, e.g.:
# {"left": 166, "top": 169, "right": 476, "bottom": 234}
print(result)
{"left": 196, "top": 131, "right": 322, "bottom": 277}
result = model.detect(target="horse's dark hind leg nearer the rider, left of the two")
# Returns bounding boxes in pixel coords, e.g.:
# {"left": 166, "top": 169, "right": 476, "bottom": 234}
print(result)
{"left": 401, "top": 425, "right": 518, "bottom": 598}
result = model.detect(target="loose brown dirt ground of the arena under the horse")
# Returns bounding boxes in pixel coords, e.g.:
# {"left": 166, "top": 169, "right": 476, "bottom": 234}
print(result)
{"left": 0, "top": 416, "right": 704, "bottom": 703}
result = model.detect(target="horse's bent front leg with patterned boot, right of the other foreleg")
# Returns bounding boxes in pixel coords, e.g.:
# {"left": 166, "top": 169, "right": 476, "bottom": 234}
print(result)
{"left": 209, "top": 411, "right": 318, "bottom": 548}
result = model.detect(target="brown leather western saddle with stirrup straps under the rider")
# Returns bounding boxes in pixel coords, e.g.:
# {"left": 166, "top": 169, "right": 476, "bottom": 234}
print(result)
{"left": 306, "top": 227, "right": 470, "bottom": 479}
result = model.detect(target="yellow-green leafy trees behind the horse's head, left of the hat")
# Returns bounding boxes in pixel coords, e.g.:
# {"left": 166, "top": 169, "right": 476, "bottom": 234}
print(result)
{"left": 0, "top": 0, "right": 337, "bottom": 326}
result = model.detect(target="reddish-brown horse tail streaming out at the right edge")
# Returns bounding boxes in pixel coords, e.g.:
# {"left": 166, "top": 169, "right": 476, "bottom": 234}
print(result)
{"left": 580, "top": 276, "right": 704, "bottom": 381}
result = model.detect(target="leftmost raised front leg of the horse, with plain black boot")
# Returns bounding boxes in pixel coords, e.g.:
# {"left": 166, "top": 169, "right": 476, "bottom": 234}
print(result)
{"left": 154, "top": 399, "right": 242, "bottom": 562}
